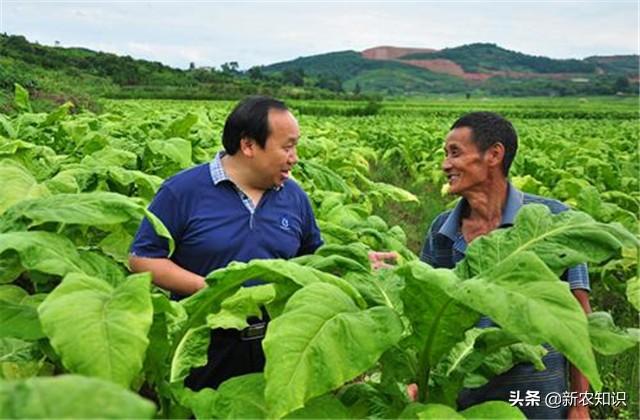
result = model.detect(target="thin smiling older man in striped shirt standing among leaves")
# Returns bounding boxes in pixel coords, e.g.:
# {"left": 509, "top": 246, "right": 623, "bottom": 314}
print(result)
{"left": 421, "top": 112, "right": 591, "bottom": 419}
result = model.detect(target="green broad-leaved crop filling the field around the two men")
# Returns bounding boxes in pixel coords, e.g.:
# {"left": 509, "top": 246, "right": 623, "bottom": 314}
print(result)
{"left": 0, "top": 89, "right": 640, "bottom": 418}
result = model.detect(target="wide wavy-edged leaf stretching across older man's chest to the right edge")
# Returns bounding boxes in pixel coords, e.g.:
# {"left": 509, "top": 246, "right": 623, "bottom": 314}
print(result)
{"left": 456, "top": 204, "right": 638, "bottom": 278}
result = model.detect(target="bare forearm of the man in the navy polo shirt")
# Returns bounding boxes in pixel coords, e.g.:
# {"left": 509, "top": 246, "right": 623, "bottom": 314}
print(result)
{"left": 129, "top": 255, "right": 206, "bottom": 296}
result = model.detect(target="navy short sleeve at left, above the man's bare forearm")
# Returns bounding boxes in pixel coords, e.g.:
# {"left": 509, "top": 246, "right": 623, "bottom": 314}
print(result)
{"left": 130, "top": 185, "right": 184, "bottom": 258}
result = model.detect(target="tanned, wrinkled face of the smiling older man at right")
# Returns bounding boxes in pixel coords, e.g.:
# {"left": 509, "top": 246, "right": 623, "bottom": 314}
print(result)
{"left": 442, "top": 127, "right": 489, "bottom": 195}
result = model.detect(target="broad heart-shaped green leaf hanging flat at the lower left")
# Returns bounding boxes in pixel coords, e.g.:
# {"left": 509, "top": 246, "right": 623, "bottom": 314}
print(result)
{"left": 38, "top": 273, "right": 153, "bottom": 387}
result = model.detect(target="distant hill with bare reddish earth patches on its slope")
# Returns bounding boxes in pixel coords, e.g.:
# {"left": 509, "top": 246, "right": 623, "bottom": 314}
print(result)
{"left": 263, "top": 43, "right": 638, "bottom": 96}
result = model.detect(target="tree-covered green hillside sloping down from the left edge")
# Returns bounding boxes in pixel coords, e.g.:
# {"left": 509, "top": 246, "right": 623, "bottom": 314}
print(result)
{"left": 0, "top": 34, "right": 348, "bottom": 111}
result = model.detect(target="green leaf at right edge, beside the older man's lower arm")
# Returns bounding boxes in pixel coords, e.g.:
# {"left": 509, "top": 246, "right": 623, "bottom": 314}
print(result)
{"left": 589, "top": 312, "right": 640, "bottom": 356}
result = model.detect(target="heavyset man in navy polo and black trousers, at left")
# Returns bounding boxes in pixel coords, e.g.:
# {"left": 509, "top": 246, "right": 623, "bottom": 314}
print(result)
{"left": 129, "top": 96, "right": 322, "bottom": 390}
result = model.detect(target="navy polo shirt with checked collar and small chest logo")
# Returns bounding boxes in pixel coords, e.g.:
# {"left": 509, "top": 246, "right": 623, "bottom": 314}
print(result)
{"left": 131, "top": 152, "right": 322, "bottom": 282}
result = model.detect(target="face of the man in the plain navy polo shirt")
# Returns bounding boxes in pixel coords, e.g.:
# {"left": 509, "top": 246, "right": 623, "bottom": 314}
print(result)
{"left": 254, "top": 109, "right": 300, "bottom": 189}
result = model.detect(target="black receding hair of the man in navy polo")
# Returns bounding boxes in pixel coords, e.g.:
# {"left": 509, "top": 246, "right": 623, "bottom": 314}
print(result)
{"left": 222, "top": 96, "right": 288, "bottom": 155}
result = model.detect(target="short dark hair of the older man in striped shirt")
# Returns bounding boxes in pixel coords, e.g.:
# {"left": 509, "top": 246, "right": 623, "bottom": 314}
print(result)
{"left": 451, "top": 112, "right": 518, "bottom": 176}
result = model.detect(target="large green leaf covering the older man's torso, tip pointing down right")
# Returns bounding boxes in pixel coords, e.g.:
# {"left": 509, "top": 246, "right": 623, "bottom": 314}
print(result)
{"left": 455, "top": 251, "right": 602, "bottom": 389}
